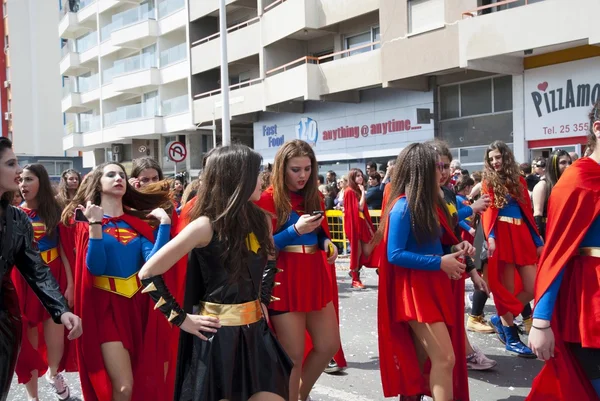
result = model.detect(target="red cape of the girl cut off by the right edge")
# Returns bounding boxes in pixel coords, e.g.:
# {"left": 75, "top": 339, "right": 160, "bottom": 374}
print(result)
{"left": 527, "top": 157, "right": 600, "bottom": 401}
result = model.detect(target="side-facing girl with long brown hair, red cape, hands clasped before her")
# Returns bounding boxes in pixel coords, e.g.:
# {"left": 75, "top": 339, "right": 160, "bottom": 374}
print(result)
{"left": 376, "top": 143, "right": 474, "bottom": 401}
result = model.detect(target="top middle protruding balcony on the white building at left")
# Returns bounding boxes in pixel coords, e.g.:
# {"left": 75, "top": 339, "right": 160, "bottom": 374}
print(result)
{"left": 110, "top": 4, "right": 158, "bottom": 49}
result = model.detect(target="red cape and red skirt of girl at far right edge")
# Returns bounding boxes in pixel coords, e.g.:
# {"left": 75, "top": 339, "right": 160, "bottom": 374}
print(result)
{"left": 527, "top": 157, "right": 600, "bottom": 401}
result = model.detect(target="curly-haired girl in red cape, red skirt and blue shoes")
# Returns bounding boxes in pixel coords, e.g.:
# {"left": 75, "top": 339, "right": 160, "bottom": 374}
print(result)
{"left": 482, "top": 141, "right": 543, "bottom": 358}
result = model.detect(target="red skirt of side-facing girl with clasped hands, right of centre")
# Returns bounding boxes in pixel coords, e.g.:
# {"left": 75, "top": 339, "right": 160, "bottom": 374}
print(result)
{"left": 392, "top": 267, "right": 456, "bottom": 326}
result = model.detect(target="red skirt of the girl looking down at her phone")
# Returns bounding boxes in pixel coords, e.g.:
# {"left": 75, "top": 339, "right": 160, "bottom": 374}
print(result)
{"left": 269, "top": 245, "right": 333, "bottom": 312}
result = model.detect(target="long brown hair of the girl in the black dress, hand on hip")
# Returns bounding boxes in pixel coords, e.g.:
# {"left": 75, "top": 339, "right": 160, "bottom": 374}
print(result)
{"left": 189, "top": 144, "right": 275, "bottom": 275}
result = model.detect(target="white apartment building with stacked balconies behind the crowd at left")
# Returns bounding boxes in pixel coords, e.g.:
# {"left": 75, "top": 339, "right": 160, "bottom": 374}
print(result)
{"left": 58, "top": 0, "right": 193, "bottom": 173}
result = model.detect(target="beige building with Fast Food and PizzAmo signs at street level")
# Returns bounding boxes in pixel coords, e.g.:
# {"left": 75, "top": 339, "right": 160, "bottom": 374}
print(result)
{"left": 189, "top": 0, "right": 600, "bottom": 172}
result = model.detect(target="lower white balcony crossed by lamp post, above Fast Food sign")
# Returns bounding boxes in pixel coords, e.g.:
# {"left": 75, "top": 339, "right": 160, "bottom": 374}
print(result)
{"left": 194, "top": 78, "right": 265, "bottom": 124}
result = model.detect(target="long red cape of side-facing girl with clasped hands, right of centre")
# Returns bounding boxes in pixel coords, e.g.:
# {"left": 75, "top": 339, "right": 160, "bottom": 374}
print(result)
{"left": 377, "top": 195, "right": 469, "bottom": 400}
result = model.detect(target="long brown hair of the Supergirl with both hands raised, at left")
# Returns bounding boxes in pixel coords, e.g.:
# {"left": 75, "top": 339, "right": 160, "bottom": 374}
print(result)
{"left": 62, "top": 162, "right": 171, "bottom": 225}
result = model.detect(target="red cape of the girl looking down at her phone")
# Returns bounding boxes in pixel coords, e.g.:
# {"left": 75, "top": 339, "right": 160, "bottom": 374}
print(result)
{"left": 256, "top": 186, "right": 348, "bottom": 368}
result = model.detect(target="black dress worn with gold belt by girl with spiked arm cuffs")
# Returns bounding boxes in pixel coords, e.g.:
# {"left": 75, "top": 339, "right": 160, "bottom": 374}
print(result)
{"left": 174, "top": 237, "right": 293, "bottom": 401}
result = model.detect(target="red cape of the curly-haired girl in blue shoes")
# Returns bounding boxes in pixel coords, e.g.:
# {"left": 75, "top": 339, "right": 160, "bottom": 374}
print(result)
{"left": 481, "top": 177, "right": 539, "bottom": 316}
